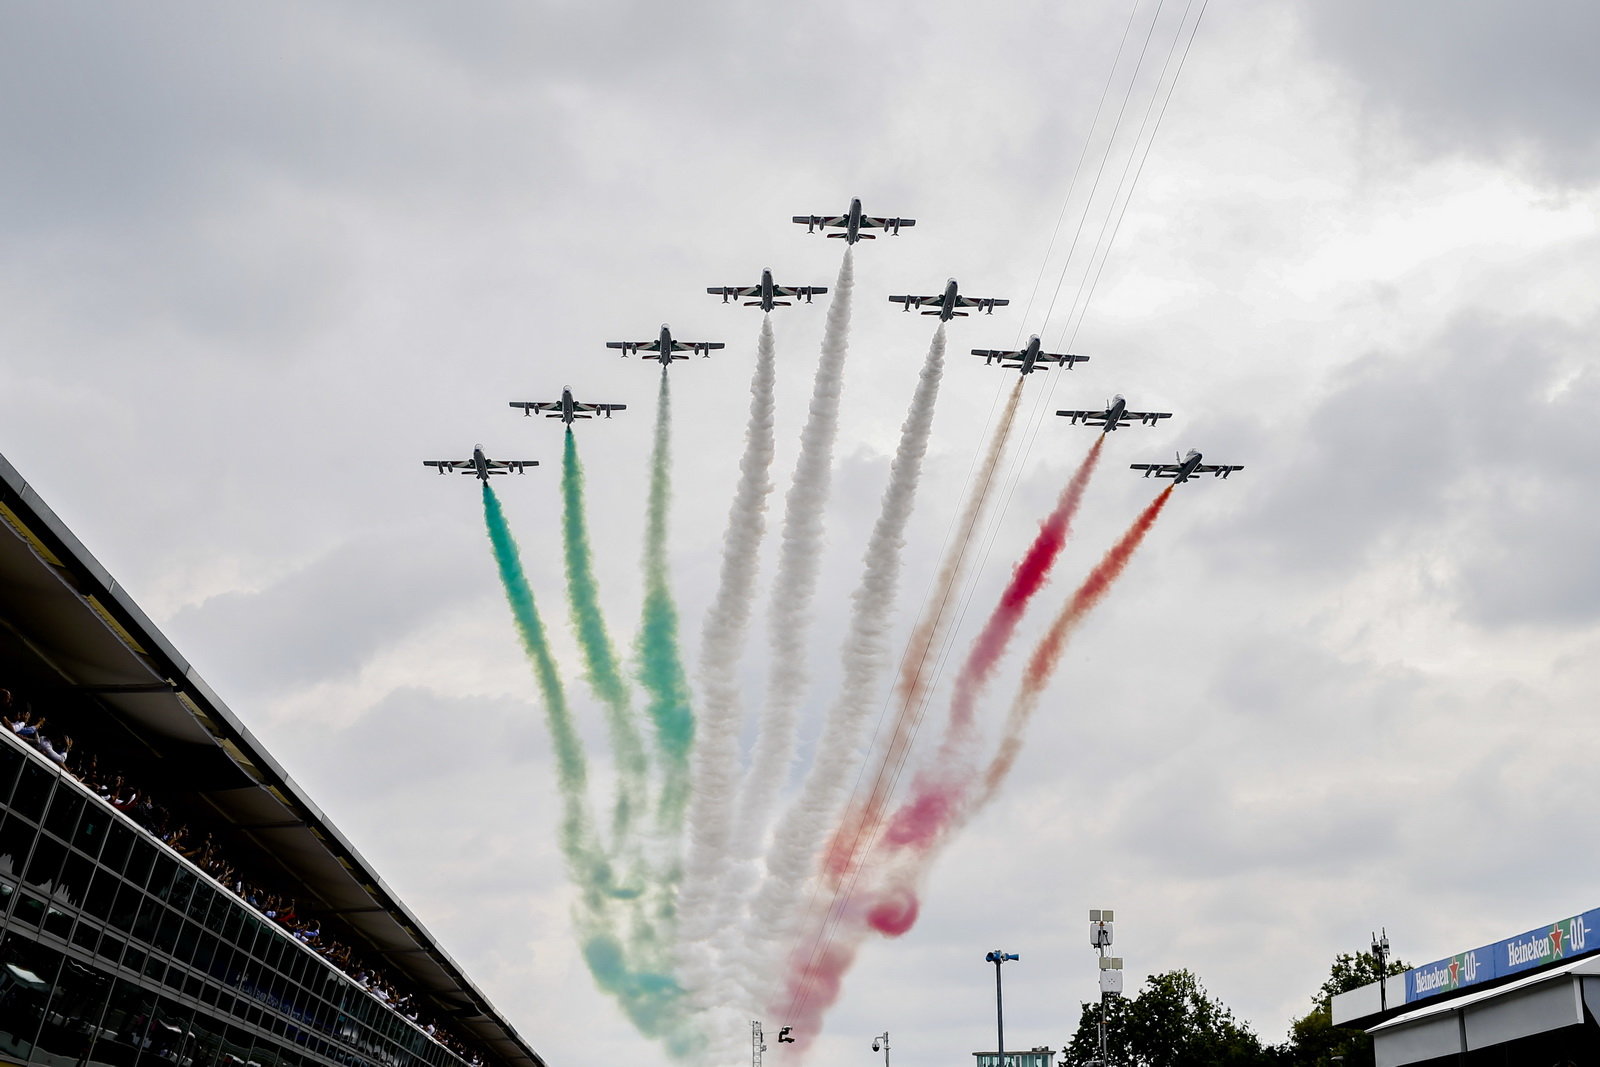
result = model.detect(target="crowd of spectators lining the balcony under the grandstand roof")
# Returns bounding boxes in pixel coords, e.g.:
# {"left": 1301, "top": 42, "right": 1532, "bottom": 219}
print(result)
{"left": 0, "top": 689, "right": 483, "bottom": 1067}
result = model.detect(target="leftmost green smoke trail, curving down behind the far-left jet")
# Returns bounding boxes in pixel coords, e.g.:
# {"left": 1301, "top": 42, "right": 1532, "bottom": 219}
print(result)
{"left": 483, "top": 483, "right": 702, "bottom": 1059}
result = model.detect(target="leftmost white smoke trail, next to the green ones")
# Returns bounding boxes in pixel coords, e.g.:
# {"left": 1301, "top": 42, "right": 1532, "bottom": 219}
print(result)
{"left": 678, "top": 317, "right": 776, "bottom": 1008}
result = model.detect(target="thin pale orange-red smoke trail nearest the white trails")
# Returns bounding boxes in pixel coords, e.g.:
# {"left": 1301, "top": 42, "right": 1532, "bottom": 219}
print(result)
{"left": 822, "top": 383, "right": 1026, "bottom": 889}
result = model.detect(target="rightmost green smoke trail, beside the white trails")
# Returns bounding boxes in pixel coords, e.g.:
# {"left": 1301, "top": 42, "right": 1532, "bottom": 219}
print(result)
{"left": 634, "top": 365, "right": 694, "bottom": 840}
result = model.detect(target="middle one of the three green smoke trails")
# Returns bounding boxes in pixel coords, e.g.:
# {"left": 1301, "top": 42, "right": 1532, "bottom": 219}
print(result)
{"left": 562, "top": 429, "right": 650, "bottom": 845}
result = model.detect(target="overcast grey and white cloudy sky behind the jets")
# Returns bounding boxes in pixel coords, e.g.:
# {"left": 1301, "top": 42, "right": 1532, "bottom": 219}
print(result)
{"left": 0, "top": 0, "right": 1600, "bottom": 1067}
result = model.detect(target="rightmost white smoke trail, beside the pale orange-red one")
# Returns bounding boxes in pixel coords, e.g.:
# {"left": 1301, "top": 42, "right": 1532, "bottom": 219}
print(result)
{"left": 742, "top": 323, "right": 944, "bottom": 1005}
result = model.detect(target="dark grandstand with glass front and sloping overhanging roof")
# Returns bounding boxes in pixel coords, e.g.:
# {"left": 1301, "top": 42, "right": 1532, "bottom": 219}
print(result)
{"left": 0, "top": 447, "right": 544, "bottom": 1067}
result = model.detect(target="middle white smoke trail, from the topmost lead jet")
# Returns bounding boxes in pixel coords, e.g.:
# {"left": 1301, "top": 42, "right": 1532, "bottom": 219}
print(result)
{"left": 723, "top": 246, "right": 854, "bottom": 921}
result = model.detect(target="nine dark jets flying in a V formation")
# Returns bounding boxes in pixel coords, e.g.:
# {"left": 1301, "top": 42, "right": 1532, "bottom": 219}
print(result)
{"left": 422, "top": 197, "right": 1243, "bottom": 485}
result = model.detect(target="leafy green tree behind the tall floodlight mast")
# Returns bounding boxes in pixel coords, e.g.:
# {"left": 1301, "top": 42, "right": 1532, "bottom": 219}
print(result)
{"left": 1062, "top": 971, "right": 1278, "bottom": 1067}
